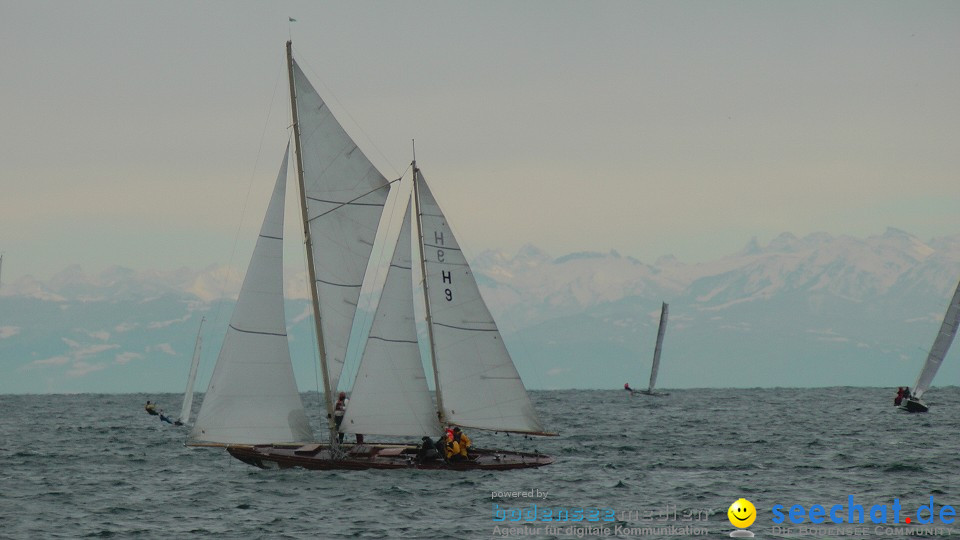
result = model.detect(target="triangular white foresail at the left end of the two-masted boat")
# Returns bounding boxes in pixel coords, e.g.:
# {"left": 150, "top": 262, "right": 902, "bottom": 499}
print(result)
{"left": 190, "top": 148, "right": 313, "bottom": 444}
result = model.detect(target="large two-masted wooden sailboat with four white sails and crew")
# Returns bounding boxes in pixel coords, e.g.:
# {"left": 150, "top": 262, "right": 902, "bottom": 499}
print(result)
{"left": 187, "top": 42, "right": 553, "bottom": 470}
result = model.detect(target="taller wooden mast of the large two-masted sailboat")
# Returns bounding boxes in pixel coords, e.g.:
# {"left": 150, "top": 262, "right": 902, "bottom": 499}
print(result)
{"left": 287, "top": 41, "right": 337, "bottom": 444}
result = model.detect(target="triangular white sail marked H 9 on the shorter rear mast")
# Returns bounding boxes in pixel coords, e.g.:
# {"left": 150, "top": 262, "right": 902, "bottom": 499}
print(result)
{"left": 414, "top": 170, "right": 544, "bottom": 433}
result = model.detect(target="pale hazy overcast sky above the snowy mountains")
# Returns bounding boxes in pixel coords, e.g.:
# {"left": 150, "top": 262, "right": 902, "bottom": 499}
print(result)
{"left": 0, "top": 4, "right": 960, "bottom": 280}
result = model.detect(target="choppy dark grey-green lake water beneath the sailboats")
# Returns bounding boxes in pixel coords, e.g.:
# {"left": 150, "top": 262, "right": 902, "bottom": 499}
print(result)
{"left": 0, "top": 388, "right": 960, "bottom": 539}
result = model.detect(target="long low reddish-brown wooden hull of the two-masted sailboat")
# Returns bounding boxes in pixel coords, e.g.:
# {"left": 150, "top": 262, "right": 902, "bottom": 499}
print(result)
{"left": 227, "top": 444, "right": 554, "bottom": 471}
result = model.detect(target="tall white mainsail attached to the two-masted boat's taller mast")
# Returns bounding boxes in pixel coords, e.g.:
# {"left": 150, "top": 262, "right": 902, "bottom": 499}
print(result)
{"left": 291, "top": 58, "right": 389, "bottom": 394}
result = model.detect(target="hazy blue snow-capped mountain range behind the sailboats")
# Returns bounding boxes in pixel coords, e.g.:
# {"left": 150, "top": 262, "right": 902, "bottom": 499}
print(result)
{"left": 0, "top": 228, "right": 960, "bottom": 393}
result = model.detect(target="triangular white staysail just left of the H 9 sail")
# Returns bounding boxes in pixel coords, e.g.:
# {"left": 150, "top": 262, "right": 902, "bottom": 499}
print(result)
{"left": 340, "top": 202, "right": 440, "bottom": 437}
